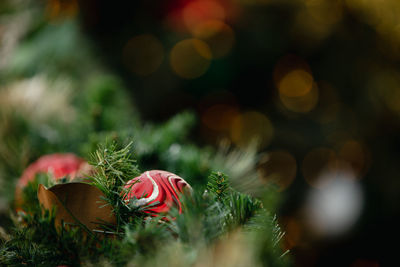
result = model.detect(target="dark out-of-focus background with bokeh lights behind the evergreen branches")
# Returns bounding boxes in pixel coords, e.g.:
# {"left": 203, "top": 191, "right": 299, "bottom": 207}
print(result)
{"left": 0, "top": 0, "right": 400, "bottom": 267}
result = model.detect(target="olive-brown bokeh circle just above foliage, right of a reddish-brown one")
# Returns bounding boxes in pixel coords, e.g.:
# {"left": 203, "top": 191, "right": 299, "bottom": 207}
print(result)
{"left": 231, "top": 111, "right": 274, "bottom": 149}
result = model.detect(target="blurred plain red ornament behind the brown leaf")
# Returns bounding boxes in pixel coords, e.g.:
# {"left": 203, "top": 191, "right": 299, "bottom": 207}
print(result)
{"left": 16, "top": 153, "right": 90, "bottom": 205}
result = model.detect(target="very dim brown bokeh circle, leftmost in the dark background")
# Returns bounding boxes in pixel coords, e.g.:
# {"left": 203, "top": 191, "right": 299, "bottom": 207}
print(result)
{"left": 123, "top": 34, "right": 164, "bottom": 75}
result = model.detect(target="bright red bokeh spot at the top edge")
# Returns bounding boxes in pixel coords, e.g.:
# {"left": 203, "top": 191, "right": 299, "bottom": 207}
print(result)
{"left": 183, "top": 0, "right": 225, "bottom": 32}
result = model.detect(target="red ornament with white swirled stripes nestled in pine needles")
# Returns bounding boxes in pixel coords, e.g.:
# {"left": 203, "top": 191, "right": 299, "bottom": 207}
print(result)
{"left": 125, "top": 170, "right": 192, "bottom": 214}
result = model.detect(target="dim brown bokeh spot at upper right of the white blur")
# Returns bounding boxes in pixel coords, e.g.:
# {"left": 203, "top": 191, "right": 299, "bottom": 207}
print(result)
{"left": 339, "top": 140, "right": 367, "bottom": 179}
